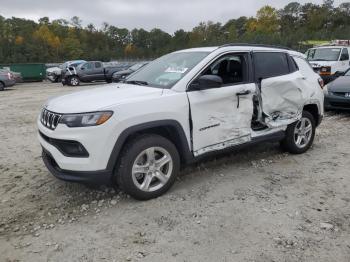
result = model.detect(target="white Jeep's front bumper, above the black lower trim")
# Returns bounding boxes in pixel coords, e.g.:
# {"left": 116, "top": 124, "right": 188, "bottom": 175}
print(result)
{"left": 37, "top": 118, "right": 118, "bottom": 172}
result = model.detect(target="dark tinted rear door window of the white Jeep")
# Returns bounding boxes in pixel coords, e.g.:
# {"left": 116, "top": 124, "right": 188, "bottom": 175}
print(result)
{"left": 253, "top": 52, "right": 290, "bottom": 80}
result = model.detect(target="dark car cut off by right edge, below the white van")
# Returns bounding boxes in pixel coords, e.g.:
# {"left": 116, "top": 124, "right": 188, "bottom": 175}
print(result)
{"left": 324, "top": 69, "right": 350, "bottom": 110}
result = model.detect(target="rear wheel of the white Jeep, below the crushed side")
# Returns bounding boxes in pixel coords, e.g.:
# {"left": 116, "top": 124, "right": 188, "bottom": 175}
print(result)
{"left": 281, "top": 111, "right": 316, "bottom": 154}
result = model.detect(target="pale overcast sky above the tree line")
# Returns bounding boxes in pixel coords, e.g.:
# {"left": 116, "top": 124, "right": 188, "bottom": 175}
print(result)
{"left": 0, "top": 0, "right": 349, "bottom": 33}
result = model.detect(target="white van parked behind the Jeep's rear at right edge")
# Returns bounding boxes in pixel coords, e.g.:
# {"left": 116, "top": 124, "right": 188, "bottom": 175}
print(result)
{"left": 306, "top": 45, "right": 350, "bottom": 82}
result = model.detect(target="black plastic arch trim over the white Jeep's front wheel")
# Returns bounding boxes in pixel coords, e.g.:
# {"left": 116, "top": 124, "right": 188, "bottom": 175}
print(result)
{"left": 107, "top": 120, "right": 194, "bottom": 170}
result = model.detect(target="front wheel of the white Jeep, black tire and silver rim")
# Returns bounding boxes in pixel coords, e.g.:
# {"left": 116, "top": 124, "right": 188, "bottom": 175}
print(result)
{"left": 113, "top": 134, "right": 180, "bottom": 200}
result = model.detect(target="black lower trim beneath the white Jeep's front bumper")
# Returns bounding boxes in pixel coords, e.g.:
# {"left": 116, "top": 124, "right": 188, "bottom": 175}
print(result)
{"left": 42, "top": 148, "right": 112, "bottom": 185}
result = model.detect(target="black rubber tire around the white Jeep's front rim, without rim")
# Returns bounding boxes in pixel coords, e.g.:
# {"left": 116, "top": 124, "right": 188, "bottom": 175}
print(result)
{"left": 114, "top": 135, "right": 180, "bottom": 200}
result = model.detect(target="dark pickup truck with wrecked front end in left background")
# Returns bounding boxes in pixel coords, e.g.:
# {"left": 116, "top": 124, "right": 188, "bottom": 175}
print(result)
{"left": 62, "top": 61, "right": 134, "bottom": 86}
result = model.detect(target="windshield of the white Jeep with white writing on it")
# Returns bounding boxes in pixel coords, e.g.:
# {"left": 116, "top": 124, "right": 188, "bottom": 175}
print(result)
{"left": 126, "top": 52, "right": 209, "bottom": 89}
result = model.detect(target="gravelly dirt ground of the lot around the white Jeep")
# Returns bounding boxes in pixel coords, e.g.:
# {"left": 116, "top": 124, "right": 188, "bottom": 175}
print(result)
{"left": 0, "top": 83, "right": 350, "bottom": 262}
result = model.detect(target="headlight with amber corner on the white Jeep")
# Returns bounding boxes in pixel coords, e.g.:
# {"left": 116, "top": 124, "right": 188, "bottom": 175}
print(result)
{"left": 60, "top": 111, "right": 113, "bottom": 127}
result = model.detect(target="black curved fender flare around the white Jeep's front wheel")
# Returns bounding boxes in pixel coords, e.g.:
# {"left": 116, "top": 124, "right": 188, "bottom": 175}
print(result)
{"left": 107, "top": 120, "right": 194, "bottom": 172}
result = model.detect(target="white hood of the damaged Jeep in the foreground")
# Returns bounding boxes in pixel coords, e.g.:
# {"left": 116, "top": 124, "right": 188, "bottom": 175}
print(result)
{"left": 46, "top": 84, "right": 163, "bottom": 114}
